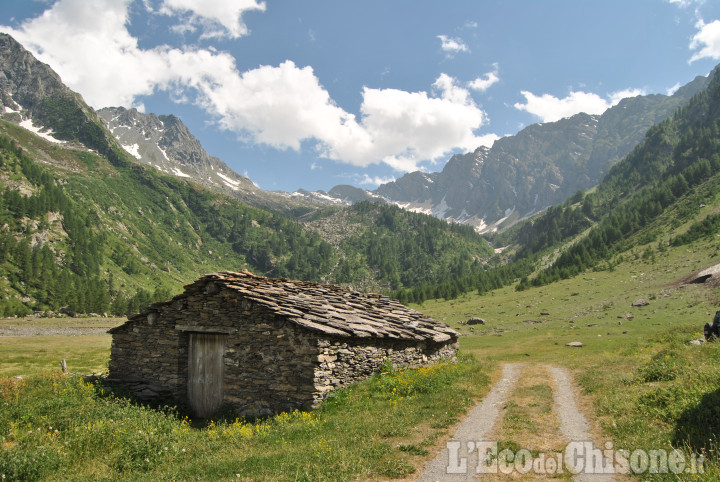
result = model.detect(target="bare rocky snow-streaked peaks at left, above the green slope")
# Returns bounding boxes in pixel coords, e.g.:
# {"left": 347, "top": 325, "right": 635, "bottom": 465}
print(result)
{"left": 0, "top": 33, "right": 317, "bottom": 217}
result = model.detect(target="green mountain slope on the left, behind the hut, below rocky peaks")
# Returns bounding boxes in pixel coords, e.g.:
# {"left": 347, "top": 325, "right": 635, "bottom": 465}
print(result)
{"left": 0, "top": 122, "right": 334, "bottom": 315}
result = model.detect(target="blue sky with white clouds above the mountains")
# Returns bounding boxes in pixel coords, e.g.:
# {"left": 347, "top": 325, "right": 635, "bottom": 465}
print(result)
{"left": 0, "top": 0, "right": 720, "bottom": 191}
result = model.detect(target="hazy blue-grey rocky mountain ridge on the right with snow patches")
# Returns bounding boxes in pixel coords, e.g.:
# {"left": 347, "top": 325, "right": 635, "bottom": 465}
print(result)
{"left": 329, "top": 76, "right": 708, "bottom": 232}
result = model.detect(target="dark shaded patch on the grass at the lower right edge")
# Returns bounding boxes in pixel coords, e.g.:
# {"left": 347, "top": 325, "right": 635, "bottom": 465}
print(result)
{"left": 673, "top": 389, "right": 720, "bottom": 452}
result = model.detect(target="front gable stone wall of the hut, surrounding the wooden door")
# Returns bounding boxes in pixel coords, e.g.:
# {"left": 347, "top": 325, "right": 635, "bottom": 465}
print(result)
{"left": 109, "top": 289, "right": 318, "bottom": 415}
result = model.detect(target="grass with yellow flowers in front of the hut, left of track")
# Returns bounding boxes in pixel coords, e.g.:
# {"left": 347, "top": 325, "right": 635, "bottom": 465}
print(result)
{"left": 0, "top": 352, "right": 489, "bottom": 480}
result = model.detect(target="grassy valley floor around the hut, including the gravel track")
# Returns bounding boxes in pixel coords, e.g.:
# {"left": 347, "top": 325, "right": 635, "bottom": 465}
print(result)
{"left": 0, "top": 237, "right": 720, "bottom": 480}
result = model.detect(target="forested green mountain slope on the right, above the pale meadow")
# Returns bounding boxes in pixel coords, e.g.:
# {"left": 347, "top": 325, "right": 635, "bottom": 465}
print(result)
{"left": 506, "top": 64, "right": 720, "bottom": 286}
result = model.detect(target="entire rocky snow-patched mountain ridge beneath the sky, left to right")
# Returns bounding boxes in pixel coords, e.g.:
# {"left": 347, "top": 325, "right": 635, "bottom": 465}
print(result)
{"left": 0, "top": 30, "right": 707, "bottom": 232}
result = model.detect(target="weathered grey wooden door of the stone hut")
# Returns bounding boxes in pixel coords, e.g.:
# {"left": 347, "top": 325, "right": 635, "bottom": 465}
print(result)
{"left": 188, "top": 333, "right": 227, "bottom": 418}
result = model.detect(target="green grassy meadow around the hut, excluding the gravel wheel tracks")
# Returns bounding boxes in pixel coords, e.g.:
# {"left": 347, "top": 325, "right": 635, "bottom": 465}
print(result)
{"left": 0, "top": 234, "right": 720, "bottom": 480}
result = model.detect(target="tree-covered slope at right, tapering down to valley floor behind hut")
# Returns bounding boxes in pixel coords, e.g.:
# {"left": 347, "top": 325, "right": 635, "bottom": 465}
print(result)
{"left": 398, "top": 63, "right": 720, "bottom": 301}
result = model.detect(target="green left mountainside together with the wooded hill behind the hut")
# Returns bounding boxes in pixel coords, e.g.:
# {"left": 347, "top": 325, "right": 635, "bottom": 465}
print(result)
{"left": 0, "top": 121, "right": 491, "bottom": 316}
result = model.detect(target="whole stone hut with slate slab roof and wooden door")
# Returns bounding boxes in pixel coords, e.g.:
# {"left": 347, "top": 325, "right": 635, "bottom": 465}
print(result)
{"left": 109, "top": 271, "right": 458, "bottom": 417}
